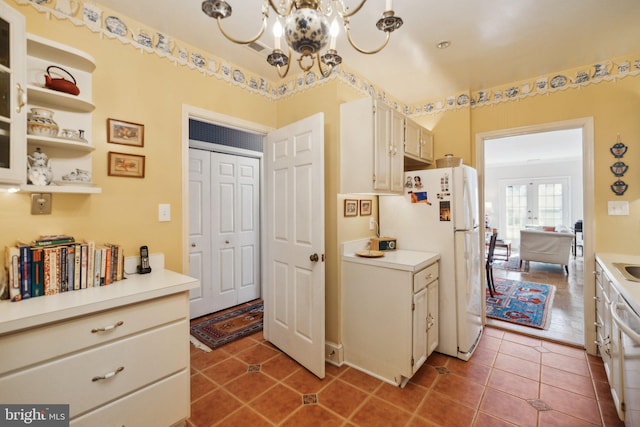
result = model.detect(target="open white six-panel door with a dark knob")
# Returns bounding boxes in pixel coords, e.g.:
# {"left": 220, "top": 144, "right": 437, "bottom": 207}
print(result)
{"left": 264, "top": 113, "right": 325, "bottom": 378}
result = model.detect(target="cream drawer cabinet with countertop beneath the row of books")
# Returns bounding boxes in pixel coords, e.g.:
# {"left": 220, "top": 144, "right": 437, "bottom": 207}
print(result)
{"left": 0, "top": 272, "right": 197, "bottom": 426}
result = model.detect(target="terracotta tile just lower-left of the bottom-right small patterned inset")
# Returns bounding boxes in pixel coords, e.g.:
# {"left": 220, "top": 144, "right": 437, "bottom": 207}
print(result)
{"left": 480, "top": 388, "right": 538, "bottom": 427}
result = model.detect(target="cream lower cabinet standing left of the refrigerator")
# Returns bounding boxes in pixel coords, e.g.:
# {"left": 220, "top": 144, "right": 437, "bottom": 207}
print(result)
{"left": 342, "top": 262, "right": 438, "bottom": 386}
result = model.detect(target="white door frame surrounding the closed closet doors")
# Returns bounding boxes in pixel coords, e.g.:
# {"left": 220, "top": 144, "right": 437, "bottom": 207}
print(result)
{"left": 180, "top": 104, "right": 273, "bottom": 294}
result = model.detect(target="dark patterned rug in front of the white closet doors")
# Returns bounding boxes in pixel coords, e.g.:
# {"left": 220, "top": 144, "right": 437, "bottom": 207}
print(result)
{"left": 191, "top": 300, "right": 264, "bottom": 351}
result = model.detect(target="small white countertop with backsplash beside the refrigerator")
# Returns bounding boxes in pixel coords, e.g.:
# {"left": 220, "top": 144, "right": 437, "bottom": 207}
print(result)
{"left": 342, "top": 239, "right": 440, "bottom": 273}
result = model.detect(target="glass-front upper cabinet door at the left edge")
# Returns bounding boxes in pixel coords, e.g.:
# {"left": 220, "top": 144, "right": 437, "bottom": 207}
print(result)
{"left": 0, "top": 3, "right": 27, "bottom": 184}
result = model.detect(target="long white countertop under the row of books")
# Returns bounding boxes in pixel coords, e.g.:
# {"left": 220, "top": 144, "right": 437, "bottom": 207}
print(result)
{"left": 0, "top": 269, "right": 198, "bottom": 334}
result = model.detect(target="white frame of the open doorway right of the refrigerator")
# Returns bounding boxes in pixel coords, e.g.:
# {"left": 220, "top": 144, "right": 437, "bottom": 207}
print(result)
{"left": 475, "top": 117, "right": 597, "bottom": 354}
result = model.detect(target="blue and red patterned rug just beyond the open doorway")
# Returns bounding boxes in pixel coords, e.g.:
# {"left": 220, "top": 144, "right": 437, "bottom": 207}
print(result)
{"left": 487, "top": 278, "right": 556, "bottom": 329}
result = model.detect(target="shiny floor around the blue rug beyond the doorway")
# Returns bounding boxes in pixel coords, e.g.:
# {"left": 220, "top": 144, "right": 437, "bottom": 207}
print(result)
{"left": 487, "top": 252, "right": 584, "bottom": 346}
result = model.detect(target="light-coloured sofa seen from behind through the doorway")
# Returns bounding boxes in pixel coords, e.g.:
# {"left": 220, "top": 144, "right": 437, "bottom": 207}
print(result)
{"left": 520, "top": 230, "right": 574, "bottom": 273}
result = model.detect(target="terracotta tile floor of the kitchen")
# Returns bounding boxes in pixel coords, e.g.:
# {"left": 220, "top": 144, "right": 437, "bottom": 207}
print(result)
{"left": 187, "top": 327, "right": 622, "bottom": 427}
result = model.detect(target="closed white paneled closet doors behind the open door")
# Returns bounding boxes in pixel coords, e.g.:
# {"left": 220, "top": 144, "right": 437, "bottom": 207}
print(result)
{"left": 189, "top": 149, "right": 261, "bottom": 318}
